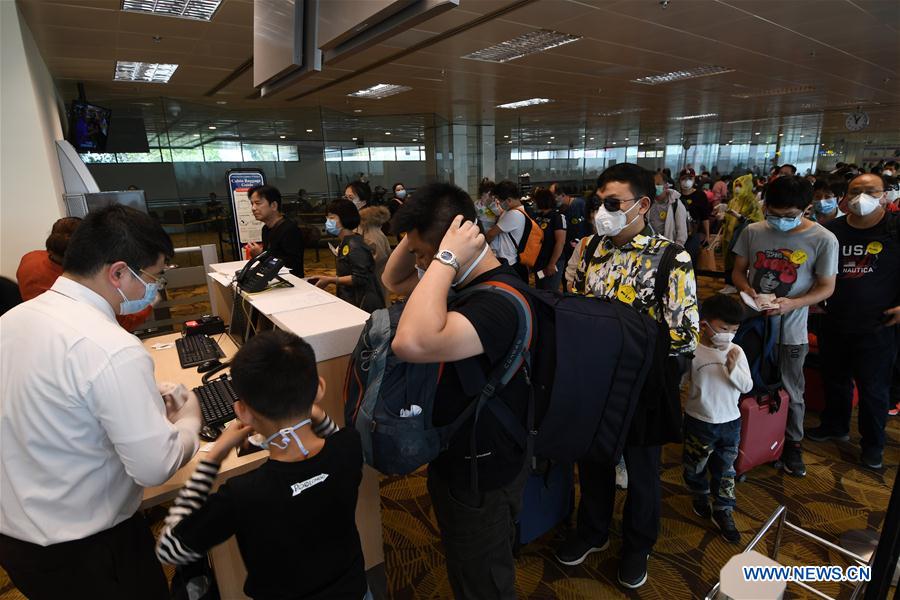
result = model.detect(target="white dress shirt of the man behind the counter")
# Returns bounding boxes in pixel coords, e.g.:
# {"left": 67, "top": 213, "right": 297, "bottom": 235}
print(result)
{"left": 0, "top": 277, "right": 198, "bottom": 546}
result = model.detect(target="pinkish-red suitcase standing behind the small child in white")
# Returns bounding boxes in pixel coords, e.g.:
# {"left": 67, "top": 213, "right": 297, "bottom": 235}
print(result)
{"left": 734, "top": 389, "right": 790, "bottom": 475}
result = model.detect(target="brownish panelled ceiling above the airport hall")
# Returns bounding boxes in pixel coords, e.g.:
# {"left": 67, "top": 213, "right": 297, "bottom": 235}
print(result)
{"left": 18, "top": 0, "right": 900, "bottom": 146}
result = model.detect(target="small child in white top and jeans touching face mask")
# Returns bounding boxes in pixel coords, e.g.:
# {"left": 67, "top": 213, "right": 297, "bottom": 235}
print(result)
{"left": 683, "top": 294, "right": 753, "bottom": 544}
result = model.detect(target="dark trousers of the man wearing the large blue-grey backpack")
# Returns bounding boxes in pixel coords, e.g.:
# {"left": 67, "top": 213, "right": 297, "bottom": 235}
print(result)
{"left": 428, "top": 465, "right": 530, "bottom": 600}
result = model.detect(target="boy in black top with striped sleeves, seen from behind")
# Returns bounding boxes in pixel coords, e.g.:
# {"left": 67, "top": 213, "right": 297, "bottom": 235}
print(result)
{"left": 156, "top": 330, "right": 370, "bottom": 600}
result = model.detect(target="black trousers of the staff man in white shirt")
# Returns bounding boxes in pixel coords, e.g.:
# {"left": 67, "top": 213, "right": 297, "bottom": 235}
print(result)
{"left": 0, "top": 513, "right": 170, "bottom": 600}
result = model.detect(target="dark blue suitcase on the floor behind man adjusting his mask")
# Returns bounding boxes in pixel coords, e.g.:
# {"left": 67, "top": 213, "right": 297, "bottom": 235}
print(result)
{"left": 516, "top": 460, "right": 575, "bottom": 546}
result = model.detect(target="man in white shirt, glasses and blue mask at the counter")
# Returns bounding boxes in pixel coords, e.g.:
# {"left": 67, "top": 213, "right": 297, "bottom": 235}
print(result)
{"left": 0, "top": 205, "right": 201, "bottom": 600}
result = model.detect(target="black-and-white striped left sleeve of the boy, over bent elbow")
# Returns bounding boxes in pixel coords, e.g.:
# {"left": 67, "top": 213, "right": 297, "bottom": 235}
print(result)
{"left": 156, "top": 461, "right": 219, "bottom": 565}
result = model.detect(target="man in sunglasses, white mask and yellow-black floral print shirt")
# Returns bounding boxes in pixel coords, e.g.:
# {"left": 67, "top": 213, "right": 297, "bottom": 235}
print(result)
{"left": 556, "top": 163, "right": 699, "bottom": 588}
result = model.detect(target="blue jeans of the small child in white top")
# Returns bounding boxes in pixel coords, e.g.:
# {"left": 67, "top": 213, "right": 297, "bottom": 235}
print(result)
{"left": 682, "top": 415, "right": 741, "bottom": 511}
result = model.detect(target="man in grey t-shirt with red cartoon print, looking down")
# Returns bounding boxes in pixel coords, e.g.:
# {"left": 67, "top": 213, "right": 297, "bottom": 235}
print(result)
{"left": 732, "top": 175, "right": 838, "bottom": 477}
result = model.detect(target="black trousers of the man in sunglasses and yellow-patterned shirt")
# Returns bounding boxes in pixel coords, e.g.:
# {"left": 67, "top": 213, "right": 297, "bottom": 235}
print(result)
{"left": 578, "top": 446, "right": 661, "bottom": 555}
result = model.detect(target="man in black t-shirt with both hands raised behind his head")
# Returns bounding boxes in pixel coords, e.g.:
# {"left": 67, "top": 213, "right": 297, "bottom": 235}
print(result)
{"left": 383, "top": 183, "right": 529, "bottom": 599}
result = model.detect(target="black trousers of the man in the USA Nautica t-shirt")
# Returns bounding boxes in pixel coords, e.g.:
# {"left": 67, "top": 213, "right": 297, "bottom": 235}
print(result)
{"left": 819, "top": 325, "right": 897, "bottom": 450}
